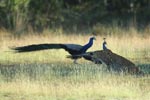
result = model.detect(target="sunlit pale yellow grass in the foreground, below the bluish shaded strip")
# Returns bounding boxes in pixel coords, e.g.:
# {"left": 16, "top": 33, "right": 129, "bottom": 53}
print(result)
{"left": 0, "top": 77, "right": 149, "bottom": 100}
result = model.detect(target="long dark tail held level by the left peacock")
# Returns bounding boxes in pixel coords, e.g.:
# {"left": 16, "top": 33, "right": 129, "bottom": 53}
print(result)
{"left": 10, "top": 44, "right": 63, "bottom": 53}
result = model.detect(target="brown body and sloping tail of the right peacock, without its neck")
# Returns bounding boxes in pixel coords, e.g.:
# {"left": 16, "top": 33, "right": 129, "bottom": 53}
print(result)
{"left": 70, "top": 49, "right": 144, "bottom": 75}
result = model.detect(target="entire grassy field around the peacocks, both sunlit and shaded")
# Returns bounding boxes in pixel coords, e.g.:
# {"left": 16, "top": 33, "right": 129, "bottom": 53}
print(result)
{"left": 0, "top": 32, "right": 150, "bottom": 100}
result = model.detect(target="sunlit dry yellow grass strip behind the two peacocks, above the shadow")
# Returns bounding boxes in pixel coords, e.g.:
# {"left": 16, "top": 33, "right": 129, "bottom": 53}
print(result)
{"left": 0, "top": 31, "right": 150, "bottom": 62}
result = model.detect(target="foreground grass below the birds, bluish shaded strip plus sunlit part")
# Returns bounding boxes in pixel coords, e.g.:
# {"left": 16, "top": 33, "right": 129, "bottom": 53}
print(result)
{"left": 0, "top": 63, "right": 150, "bottom": 100}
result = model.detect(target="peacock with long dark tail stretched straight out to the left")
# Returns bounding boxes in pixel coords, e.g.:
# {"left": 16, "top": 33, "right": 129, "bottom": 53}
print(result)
{"left": 11, "top": 37, "right": 96, "bottom": 63}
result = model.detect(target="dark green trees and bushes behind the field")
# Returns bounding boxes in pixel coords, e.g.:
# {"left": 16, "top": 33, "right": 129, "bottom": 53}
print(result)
{"left": 0, "top": 0, "right": 150, "bottom": 34}
